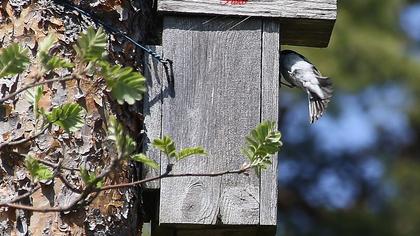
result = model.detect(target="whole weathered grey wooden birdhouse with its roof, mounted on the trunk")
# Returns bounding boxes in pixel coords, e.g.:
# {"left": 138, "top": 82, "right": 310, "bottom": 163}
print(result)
{"left": 144, "top": 0, "right": 337, "bottom": 236}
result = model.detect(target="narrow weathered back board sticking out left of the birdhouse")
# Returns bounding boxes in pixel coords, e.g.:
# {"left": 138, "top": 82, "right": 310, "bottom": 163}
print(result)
{"left": 143, "top": 46, "right": 164, "bottom": 189}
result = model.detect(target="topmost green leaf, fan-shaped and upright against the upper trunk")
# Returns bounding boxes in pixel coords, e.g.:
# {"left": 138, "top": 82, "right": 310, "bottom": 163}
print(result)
{"left": 74, "top": 27, "right": 107, "bottom": 62}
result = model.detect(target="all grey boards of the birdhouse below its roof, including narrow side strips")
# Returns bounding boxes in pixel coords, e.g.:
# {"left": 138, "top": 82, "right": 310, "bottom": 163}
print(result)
{"left": 146, "top": 16, "right": 279, "bottom": 228}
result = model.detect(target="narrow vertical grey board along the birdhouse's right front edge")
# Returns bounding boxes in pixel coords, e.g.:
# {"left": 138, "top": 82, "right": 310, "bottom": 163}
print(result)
{"left": 260, "top": 19, "right": 280, "bottom": 225}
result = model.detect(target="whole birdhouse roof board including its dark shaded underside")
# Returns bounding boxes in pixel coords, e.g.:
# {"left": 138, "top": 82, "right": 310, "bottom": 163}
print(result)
{"left": 158, "top": 0, "right": 337, "bottom": 47}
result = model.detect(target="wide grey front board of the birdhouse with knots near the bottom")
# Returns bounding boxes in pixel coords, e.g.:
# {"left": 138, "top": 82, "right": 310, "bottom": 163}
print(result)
{"left": 160, "top": 16, "right": 262, "bottom": 224}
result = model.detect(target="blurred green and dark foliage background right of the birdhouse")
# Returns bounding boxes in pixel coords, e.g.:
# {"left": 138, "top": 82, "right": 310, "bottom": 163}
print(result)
{"left": 279, "top": 0, "right": 420, "bottom": 236}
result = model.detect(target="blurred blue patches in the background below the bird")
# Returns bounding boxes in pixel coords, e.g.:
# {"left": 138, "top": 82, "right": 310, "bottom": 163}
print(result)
{"left": 279, "top": 84, "right": 413, "bottom": 208}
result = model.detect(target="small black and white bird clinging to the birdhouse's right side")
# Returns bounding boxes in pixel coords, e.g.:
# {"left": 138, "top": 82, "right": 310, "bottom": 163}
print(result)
{"left": 280, "top": 50, "right": 333, "bottom": 123}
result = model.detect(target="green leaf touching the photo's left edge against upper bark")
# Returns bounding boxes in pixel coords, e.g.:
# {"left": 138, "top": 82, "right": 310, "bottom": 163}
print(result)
{"left": 0, "top": 43, "right": 29, "bottom": 78}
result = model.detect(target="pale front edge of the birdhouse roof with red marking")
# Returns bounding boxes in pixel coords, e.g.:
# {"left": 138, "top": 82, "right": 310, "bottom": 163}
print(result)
{"left": 158, "top": 0, "right": 337, "bottom": 20}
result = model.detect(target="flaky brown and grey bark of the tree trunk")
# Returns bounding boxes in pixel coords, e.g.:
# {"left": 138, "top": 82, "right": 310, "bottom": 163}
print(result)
{"left": 0, "top": 0, "right": 159, "bottom": 235}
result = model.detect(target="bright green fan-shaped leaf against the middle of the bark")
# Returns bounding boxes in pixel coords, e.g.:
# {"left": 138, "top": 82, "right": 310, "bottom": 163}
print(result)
{"left": 47, "top": 103, "right": 86, "bottom": 132}
